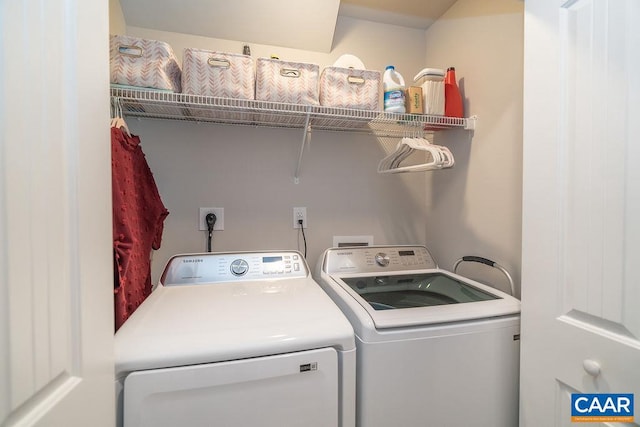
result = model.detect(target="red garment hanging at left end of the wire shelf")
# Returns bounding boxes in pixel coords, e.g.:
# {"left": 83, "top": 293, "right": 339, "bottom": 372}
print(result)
{"left": 111, "top": 128, "right": 169, "bottom": 330}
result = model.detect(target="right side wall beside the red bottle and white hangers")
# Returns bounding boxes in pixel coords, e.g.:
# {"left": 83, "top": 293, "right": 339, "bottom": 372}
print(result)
{"left": 426, "top": 0, "right": 524, "bottom": 294}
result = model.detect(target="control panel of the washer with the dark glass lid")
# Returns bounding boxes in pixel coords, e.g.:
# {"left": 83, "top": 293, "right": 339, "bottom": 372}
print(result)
{"left": 322, "top": 246, "right": 438, "bottom": 274}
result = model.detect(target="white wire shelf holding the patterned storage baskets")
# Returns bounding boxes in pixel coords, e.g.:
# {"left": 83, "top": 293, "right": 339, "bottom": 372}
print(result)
{"left": 111, "top": 88, "right": 475, "bottom": 138}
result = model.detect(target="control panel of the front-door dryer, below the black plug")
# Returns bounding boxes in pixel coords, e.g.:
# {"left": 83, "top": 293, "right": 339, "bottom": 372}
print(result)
{"left": 160, "top": 251, "right": 309, "bottom": 286}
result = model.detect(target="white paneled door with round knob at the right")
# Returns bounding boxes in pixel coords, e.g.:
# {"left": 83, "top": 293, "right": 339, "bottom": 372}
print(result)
{"left": 520, "top": 0, "right": 640, "bottom": 427}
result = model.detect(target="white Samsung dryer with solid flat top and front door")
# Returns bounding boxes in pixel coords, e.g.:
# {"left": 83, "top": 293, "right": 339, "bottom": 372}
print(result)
{"left": 115, "top": 251, "right": 356, "bottom": 427}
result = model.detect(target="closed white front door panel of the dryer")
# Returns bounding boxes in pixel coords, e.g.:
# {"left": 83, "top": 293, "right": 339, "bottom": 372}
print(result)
{"left": 124, "top": 350, "right": 338, "bottom": 427}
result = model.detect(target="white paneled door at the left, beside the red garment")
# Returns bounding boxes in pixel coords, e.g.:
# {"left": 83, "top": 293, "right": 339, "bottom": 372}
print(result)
{"left": 0, "top": 0, "right": 115, "bottom": 427}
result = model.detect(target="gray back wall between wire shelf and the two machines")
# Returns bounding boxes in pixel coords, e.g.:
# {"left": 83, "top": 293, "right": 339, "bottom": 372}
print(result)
{"left": 129, "top": 121, "right": 424, "bottom": 284}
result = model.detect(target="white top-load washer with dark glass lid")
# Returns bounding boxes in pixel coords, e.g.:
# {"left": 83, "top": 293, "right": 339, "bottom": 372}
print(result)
{"left": 316, "top": 246, "right": 520, "bottom": 427}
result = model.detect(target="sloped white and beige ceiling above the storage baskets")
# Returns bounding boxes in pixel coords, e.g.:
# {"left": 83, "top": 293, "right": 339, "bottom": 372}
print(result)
{"left": 120, "top": 0, "right": 456, "bottom": 52}
